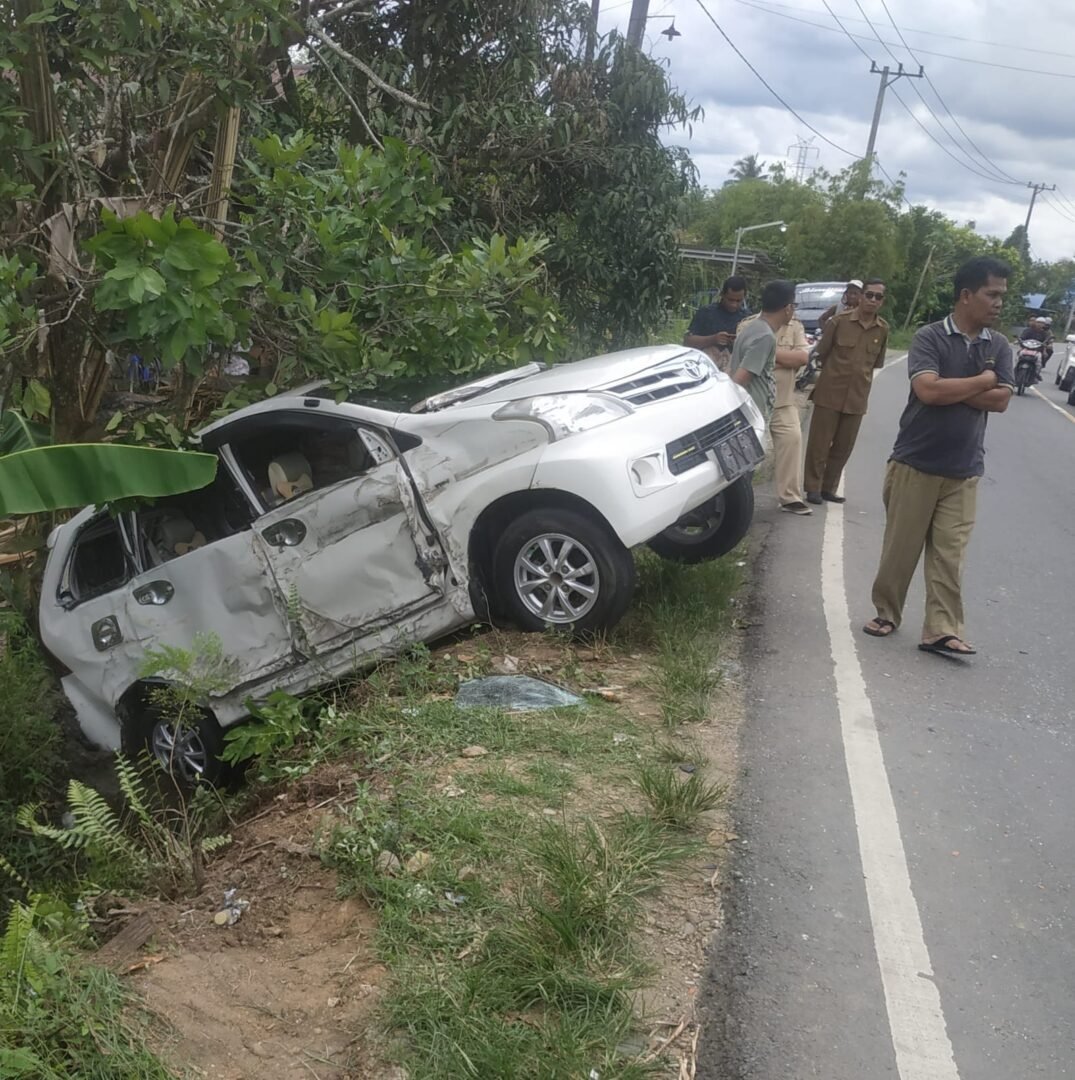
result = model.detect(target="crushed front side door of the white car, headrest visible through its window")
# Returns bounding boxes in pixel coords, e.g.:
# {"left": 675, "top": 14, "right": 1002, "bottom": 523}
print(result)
{"left": 228, "top": 414, "right": 446, "bottom": 656}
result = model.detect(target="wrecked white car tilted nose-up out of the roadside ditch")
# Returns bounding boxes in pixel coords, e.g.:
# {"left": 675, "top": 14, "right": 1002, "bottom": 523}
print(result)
{"left": 40, "top": 346, "right": 764, "bottom": 781}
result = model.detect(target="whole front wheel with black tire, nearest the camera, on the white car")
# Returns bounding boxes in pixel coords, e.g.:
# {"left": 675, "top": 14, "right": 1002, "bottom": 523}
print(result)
{"left": 493, "top": 507, "right": 634, "bottom": 637}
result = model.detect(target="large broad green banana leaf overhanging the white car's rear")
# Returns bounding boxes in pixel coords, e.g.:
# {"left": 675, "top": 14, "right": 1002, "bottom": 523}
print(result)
{"left": 0, "top": 443, "right": 216, "bottom": 515}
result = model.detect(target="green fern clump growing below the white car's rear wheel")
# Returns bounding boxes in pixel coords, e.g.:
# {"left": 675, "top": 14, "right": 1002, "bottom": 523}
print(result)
{"left": 17, "top": 755, "right": 227, "bottom": 895}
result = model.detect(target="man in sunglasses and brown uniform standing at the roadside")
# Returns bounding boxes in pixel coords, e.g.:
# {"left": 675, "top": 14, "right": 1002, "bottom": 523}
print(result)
{"left": 803, "top": 278, "right": 888, "bottom": 505}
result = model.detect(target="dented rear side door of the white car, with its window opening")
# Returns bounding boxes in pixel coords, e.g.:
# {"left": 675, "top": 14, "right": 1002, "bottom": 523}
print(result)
{"left": 126, "top": 462, "right": 296, "bottom": 693}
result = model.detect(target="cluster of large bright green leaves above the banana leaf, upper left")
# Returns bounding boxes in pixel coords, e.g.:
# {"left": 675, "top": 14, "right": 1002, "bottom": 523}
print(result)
{"left": 85, "top": 206, "right": 258, "bottom": 374}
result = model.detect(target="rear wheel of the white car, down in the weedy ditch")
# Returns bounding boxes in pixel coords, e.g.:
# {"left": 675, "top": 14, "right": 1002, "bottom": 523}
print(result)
{"left": 122, "top": 703, "right": 228, "bottom": 789}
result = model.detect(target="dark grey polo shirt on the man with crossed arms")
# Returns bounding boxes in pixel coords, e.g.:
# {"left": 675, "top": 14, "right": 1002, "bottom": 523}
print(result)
{"left": 891, "top": 315, "right": 1014, "bottom": 480}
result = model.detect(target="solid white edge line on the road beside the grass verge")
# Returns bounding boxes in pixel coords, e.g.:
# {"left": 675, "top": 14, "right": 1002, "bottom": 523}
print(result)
{"left": 821, "top": 505, "right": 959, "bottom": 1080}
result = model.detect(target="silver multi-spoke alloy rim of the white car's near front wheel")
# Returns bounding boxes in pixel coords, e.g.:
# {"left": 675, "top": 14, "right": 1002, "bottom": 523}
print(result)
{"left": 514, "top": 532, "right": 601, "bottom": 625}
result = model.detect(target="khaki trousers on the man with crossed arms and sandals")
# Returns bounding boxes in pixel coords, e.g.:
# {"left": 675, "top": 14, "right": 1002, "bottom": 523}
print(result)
{"left": 873, "top": 461, "right": 978, "bottom": 638}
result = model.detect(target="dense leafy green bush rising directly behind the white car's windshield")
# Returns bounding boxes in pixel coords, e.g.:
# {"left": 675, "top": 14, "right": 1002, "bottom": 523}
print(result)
{"left": 241, "top": 133, "right": 562, "bottom": 386}
